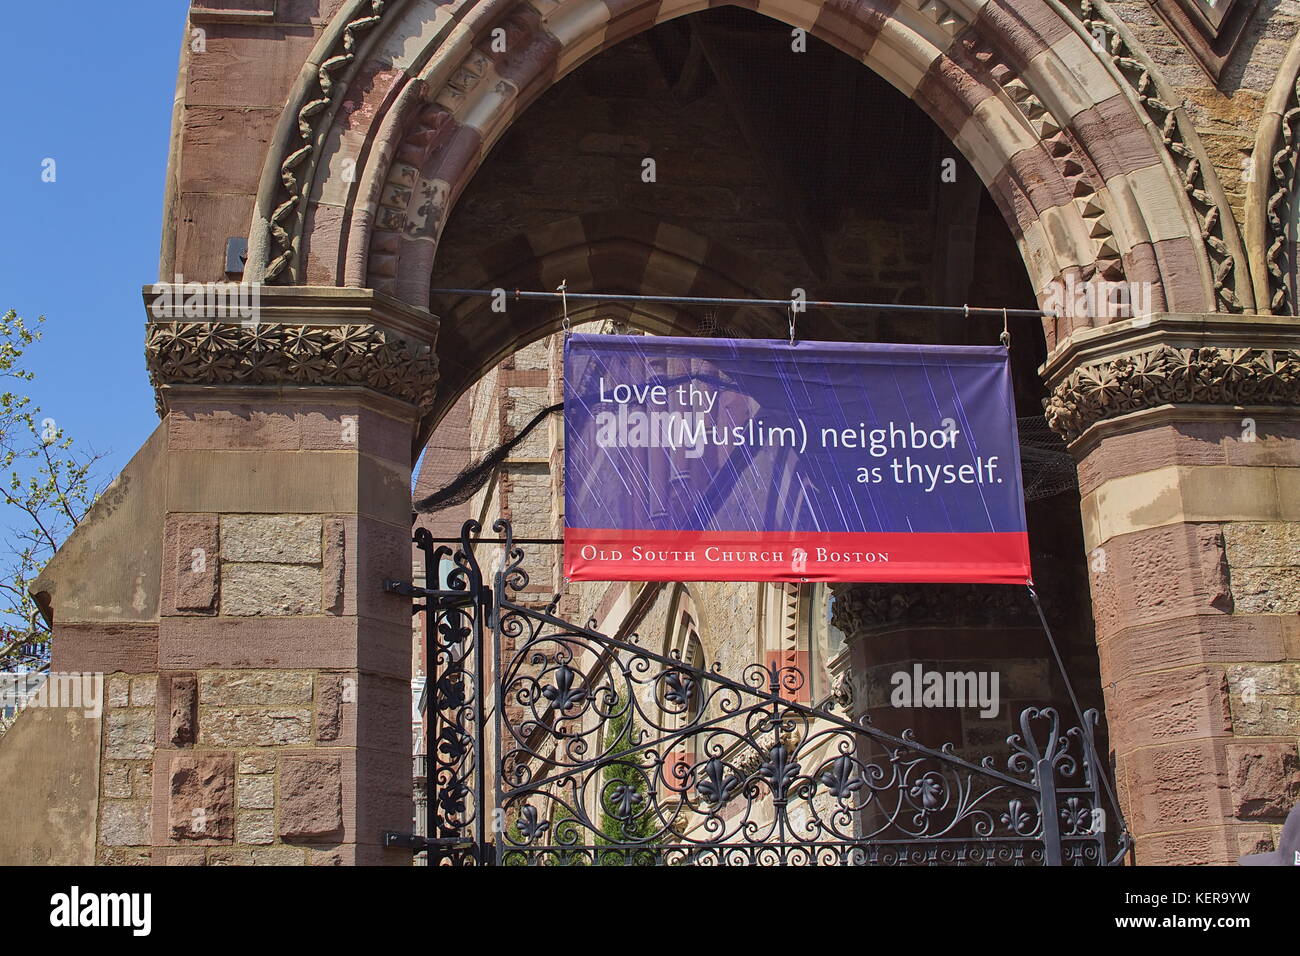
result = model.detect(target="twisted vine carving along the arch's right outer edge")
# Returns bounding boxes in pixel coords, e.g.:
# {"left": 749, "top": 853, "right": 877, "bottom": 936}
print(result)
{"left": 1063, "top": 0, "right": 1243, "bottom": 312}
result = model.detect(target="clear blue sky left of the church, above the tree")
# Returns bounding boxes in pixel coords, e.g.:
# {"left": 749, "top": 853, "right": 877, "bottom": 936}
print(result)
{"left": 0, "top": 0, "right": 189, "bottom": 479}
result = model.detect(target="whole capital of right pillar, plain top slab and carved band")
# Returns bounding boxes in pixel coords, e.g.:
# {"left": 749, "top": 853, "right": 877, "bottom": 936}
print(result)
{"left": 1044, "top": 315, "right": 1300, "bottom": 441}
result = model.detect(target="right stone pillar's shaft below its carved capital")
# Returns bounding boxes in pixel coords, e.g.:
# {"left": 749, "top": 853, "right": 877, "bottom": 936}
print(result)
{"left": 1079, "top": 408, "right": 1300, "bottom": 864}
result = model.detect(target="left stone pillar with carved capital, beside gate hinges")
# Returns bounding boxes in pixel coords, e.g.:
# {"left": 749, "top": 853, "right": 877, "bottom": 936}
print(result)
{"left": 42, "top": 287, "right": 437, "bottom": 865}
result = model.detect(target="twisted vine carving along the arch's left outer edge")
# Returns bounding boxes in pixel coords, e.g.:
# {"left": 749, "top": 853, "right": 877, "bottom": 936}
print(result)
{"left": 263, "top": 0, "right": 389, "bottom": 282}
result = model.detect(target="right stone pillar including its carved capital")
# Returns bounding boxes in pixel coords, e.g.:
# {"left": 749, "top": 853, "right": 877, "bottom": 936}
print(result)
{"left": 1044, "top": 315, "right": 1300, "bottom": 864}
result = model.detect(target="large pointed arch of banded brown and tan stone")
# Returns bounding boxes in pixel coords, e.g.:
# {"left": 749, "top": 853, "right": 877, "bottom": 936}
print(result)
{"left": 250, "top": 0, "right": 1253, "bottom": 332}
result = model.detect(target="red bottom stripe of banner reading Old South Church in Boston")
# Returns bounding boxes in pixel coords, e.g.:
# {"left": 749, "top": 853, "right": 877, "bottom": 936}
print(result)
{"left": 564, "top": 528, "right": 1032, "bottom": 584}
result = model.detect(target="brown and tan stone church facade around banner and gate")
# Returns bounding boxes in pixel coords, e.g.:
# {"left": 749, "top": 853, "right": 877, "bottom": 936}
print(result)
{"left": 0, "top": 0, "right": 1300, "bottom": 865}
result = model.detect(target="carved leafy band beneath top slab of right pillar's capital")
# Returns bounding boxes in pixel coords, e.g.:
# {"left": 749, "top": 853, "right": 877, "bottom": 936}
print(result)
{"left": 1044, "top": 345, "right": 1300, "bottom": 441}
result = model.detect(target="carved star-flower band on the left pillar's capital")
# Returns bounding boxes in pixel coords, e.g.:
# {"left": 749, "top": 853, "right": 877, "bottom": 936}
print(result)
{"left": 144, "top": 323, "right": 438, "bottom": 411}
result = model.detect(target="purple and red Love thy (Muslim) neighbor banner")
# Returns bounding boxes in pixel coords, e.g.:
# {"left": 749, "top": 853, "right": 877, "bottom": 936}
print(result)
{"left": 564, "top": 334, "right": 1030, "bottom": 584}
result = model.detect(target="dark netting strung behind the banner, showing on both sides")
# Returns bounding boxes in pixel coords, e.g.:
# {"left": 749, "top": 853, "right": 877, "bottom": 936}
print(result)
{"left": 415, "top": 402, "right": 1078, "bottom": 514}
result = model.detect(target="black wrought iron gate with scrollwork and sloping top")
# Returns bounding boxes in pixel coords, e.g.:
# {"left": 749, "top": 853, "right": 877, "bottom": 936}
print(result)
{"left": 385, "top": 522, "right": 1130, "bottom": 866}
